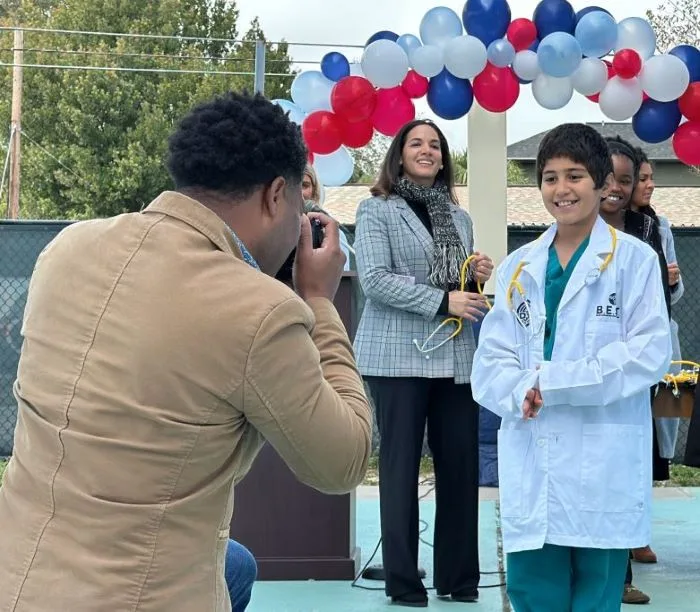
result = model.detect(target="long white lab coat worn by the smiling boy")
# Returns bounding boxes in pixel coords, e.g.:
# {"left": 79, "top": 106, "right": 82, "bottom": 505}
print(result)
{"left": 471, "top": 218, "right": 671, "bottom": 552}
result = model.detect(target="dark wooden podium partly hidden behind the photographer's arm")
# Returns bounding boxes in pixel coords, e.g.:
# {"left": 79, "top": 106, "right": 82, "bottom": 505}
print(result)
{"left": 230, "top": 272, "right": 360, "bottom": 580}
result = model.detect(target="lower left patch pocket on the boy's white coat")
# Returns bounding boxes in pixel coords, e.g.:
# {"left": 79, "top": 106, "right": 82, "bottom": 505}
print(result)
{"left": 498, "top": 429, "right": 532, "bottom": 518}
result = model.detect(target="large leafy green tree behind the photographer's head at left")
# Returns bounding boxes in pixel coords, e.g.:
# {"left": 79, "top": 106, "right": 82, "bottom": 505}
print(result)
{"left": 0, "top": 0, "right": 293, "bottom": 219}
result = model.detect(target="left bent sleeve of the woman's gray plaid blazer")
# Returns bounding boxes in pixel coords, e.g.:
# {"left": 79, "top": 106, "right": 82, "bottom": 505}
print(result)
{"left": 355, "top": 199, "right": 445, "bottom": 320}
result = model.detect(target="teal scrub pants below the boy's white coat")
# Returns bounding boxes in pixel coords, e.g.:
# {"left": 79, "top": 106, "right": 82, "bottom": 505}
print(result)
{"left": 506, "top": 544, "right": 629, "bottom": 612}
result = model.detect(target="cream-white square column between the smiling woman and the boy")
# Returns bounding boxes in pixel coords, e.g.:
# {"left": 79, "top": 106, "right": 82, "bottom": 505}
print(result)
{"left": 467, "top": 100, "right": 508, "bottom": 294}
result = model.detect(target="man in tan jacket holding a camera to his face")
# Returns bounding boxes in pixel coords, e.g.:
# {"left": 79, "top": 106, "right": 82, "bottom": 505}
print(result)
{"left": 0, "top": 94, "right": 371, "bottom": 612}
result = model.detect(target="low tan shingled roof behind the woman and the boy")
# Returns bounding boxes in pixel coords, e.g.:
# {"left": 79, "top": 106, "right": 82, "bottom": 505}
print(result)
{"left": 323, "top": 185, "right": 700, "bottom": 227}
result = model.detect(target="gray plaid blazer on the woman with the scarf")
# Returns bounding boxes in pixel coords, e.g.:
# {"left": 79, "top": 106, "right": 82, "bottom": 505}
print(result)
{"left": 354, "top": 196, "right": 476, "bottom": 383}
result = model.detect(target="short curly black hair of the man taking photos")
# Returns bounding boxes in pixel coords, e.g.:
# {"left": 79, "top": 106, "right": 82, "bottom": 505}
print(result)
{"left": 167, "top": 92, "right": 307, "bottom": 199}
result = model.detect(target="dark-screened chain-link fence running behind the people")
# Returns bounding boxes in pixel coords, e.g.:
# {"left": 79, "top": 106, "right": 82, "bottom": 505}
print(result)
{"left": 0, "top": 221, "right": 700, "bottom": 458}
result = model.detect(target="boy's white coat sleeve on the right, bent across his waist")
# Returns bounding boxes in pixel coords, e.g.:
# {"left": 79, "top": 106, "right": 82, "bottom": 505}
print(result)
{"left": 539, "top": 252, "right": 671, "bottom": 408}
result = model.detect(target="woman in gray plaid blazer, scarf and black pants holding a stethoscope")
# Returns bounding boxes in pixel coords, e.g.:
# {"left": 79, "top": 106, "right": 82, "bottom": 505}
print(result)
{"left": 355, "top": 120, "right": 493, "bottom": 607}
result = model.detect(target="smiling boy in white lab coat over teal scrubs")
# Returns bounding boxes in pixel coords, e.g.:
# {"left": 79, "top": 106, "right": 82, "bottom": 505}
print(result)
{"left": 471, "top": 124, "right": 671, "bottom": 612}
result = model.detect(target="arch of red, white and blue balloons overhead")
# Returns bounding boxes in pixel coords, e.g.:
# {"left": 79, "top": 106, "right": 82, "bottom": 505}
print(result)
{"left": 275, "top": 0, "right": 700, "bottom": 186}
